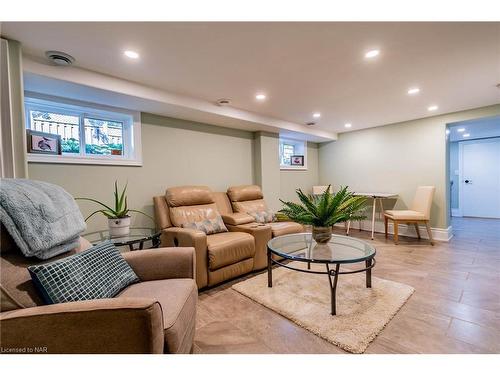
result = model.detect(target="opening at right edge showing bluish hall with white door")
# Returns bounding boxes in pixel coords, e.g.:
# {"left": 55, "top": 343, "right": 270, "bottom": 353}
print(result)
{"left": 447, "top": 116, "right": 500, "bottom": 219}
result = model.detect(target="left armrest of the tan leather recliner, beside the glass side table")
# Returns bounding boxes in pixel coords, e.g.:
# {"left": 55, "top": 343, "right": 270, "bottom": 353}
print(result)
{"left": 161, "top": 227, "right": 208, "bottom": 289}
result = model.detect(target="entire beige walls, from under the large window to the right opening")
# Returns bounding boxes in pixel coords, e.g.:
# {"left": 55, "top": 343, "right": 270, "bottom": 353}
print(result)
{"left": 32, "top": 100, "right": 500, "bottom": 231}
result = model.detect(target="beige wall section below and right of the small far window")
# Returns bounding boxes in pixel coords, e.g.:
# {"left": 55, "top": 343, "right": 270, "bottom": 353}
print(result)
{"left": 280, "top": 142, "right": 319, "bottom": 201}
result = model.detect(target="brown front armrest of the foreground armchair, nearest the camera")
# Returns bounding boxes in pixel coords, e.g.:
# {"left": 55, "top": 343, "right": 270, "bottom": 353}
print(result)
{"left": 0, "top": 298, "right": 164, "bottom": 354}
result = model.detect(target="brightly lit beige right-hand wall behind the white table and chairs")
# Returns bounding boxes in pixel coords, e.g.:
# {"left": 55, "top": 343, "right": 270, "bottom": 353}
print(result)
{"left": 319, "top": 105, "right": 500, "bottom": 228}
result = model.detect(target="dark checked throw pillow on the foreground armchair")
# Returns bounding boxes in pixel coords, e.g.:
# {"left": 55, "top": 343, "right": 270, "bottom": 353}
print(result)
{"left": 28, "top": 241, "right": 140, "bottom": 304}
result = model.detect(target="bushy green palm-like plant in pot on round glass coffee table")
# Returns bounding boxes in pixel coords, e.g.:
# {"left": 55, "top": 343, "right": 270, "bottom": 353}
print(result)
{"left": 279, "top": 186, "right": 366, "bottom": 243}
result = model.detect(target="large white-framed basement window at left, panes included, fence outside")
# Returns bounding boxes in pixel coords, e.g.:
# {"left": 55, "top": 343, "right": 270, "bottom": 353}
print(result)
{"left": 25, "top": 96, "right": 142, "bottom": 165}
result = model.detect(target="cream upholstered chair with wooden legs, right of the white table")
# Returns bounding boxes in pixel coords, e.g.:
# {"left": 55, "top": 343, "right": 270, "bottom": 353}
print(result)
{"left": 384, "top": 186, "right": 436, "bottom": 245}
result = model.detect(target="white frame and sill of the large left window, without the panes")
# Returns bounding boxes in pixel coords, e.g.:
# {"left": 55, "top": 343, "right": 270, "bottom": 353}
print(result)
{"left": 24, "top": 93, "right": 142, "bottom": 166}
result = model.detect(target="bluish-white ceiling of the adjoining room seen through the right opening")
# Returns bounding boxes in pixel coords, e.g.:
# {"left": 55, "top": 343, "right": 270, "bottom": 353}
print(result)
{"left": 448, "top": 116, "right": 500, "bottom": 142}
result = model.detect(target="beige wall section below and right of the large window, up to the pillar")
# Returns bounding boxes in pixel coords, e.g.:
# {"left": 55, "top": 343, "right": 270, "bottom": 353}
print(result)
{"left": 29, "top": 114, "right": 254, "bottom": 231}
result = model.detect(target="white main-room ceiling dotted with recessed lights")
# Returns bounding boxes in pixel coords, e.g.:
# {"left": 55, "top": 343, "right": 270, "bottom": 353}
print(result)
{"left": 2, "top": 22, "right": 500, "bottom": 132}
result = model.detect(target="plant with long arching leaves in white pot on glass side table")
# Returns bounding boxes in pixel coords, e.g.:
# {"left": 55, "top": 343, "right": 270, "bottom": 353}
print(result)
{"left": 75, "top": 181, "right": 154, "bottom": 237}
